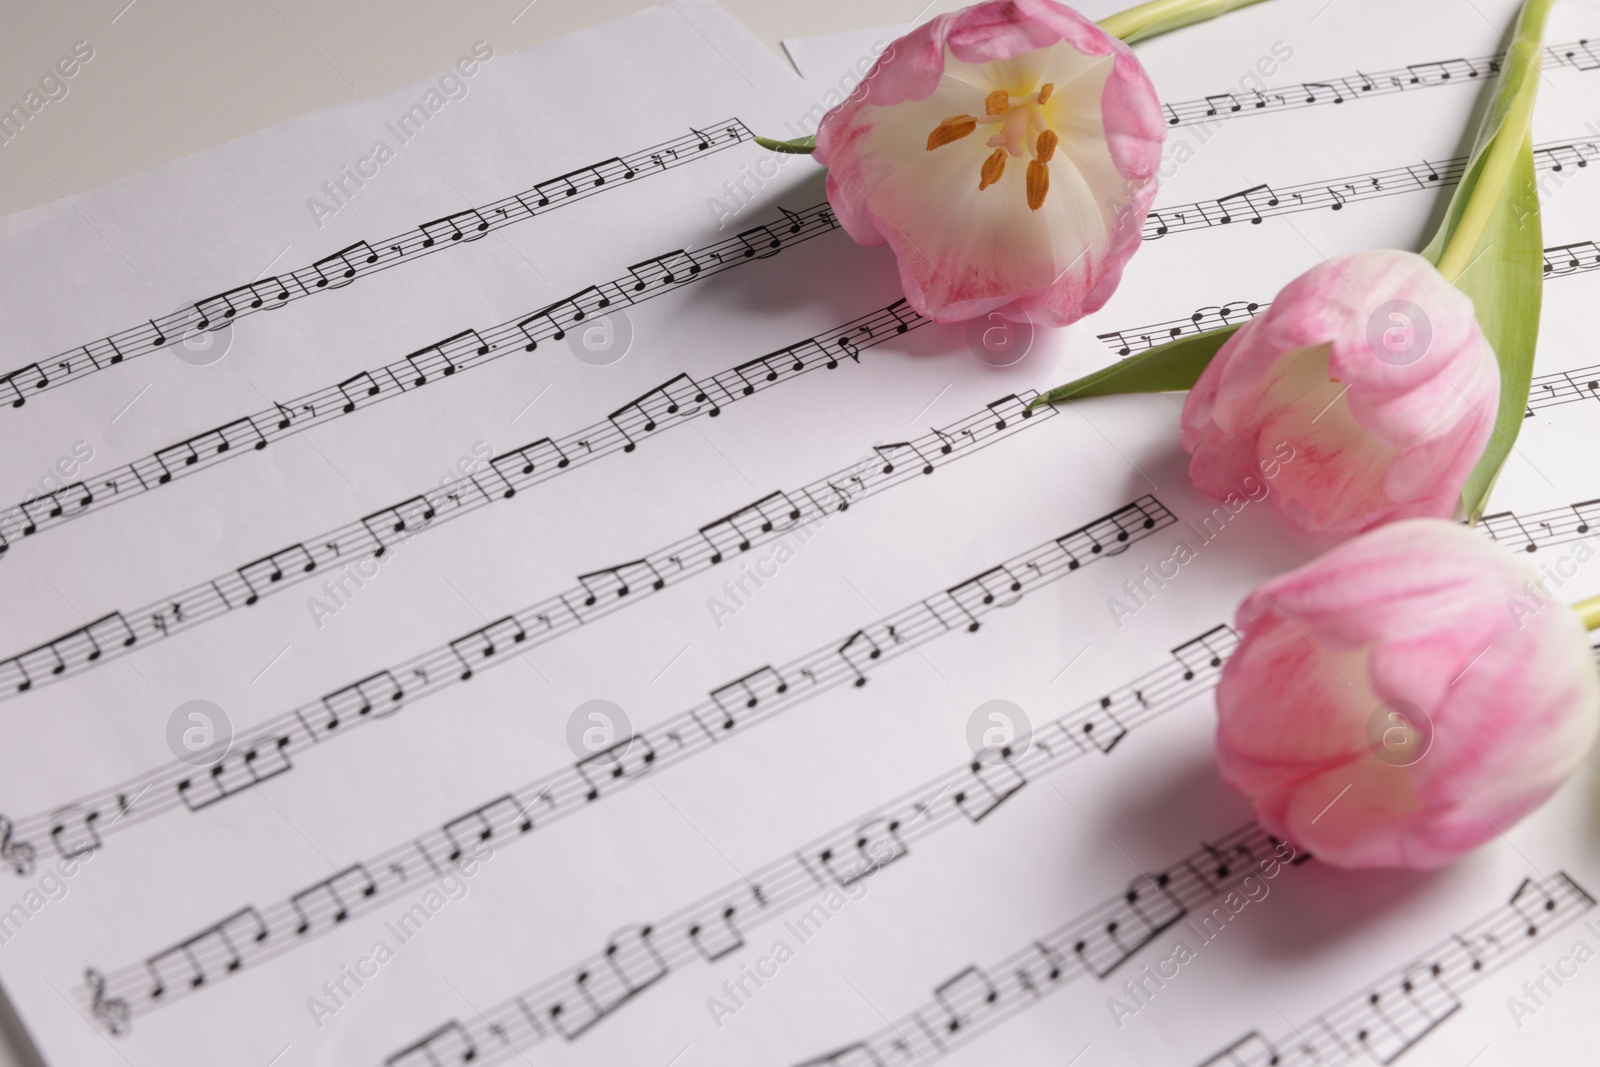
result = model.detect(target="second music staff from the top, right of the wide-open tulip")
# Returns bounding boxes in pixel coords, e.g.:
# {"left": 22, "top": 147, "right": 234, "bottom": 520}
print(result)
{"left": 1144, "top": 139, "right": 1600, "bottom": 242}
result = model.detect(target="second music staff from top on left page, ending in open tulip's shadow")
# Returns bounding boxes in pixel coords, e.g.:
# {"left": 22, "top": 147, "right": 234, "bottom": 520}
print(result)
{"left": 0, "top": 202, "right": 851, "bottom": 553}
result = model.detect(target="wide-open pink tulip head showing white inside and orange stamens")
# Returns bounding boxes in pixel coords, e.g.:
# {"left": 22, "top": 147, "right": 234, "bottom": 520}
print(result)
{"left": 816, "top": 0, "right": 1166, "bottom": 326}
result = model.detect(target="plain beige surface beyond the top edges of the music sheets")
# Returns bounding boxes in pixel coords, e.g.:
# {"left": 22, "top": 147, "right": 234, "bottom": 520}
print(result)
{"left": 0, "top": 0, "right": 934, "bottom": 1067}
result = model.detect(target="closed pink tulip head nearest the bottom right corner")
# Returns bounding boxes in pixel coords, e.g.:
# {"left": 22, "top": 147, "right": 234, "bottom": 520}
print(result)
{"left": 1216, "top": 518, "right": 1600, "bottom": 869}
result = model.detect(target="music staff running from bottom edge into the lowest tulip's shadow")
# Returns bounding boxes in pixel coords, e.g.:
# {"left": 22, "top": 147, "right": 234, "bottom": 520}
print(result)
{"left": 797, "top": 822, "right": 1310, "bottom": 1067}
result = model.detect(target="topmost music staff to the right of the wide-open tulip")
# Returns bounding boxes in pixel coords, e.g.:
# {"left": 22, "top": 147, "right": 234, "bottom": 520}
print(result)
{"left": 1162, "top": 38, "right": 1600, "bottom": 126}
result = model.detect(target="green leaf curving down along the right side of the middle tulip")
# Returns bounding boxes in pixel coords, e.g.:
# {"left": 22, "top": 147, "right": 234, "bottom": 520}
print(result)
{"left": 1456, "top": 138, "right": 1544, "bottom": 522}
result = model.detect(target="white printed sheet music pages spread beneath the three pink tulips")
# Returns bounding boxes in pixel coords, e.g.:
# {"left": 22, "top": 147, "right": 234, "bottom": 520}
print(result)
{"left": 0, "top": 0, "right": 1600, "bottom": 1067}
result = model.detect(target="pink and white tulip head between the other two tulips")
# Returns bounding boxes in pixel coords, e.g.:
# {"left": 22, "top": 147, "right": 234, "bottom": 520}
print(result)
{"left": 1182, "top": 250, "right": 1499, "bottom": 534}
